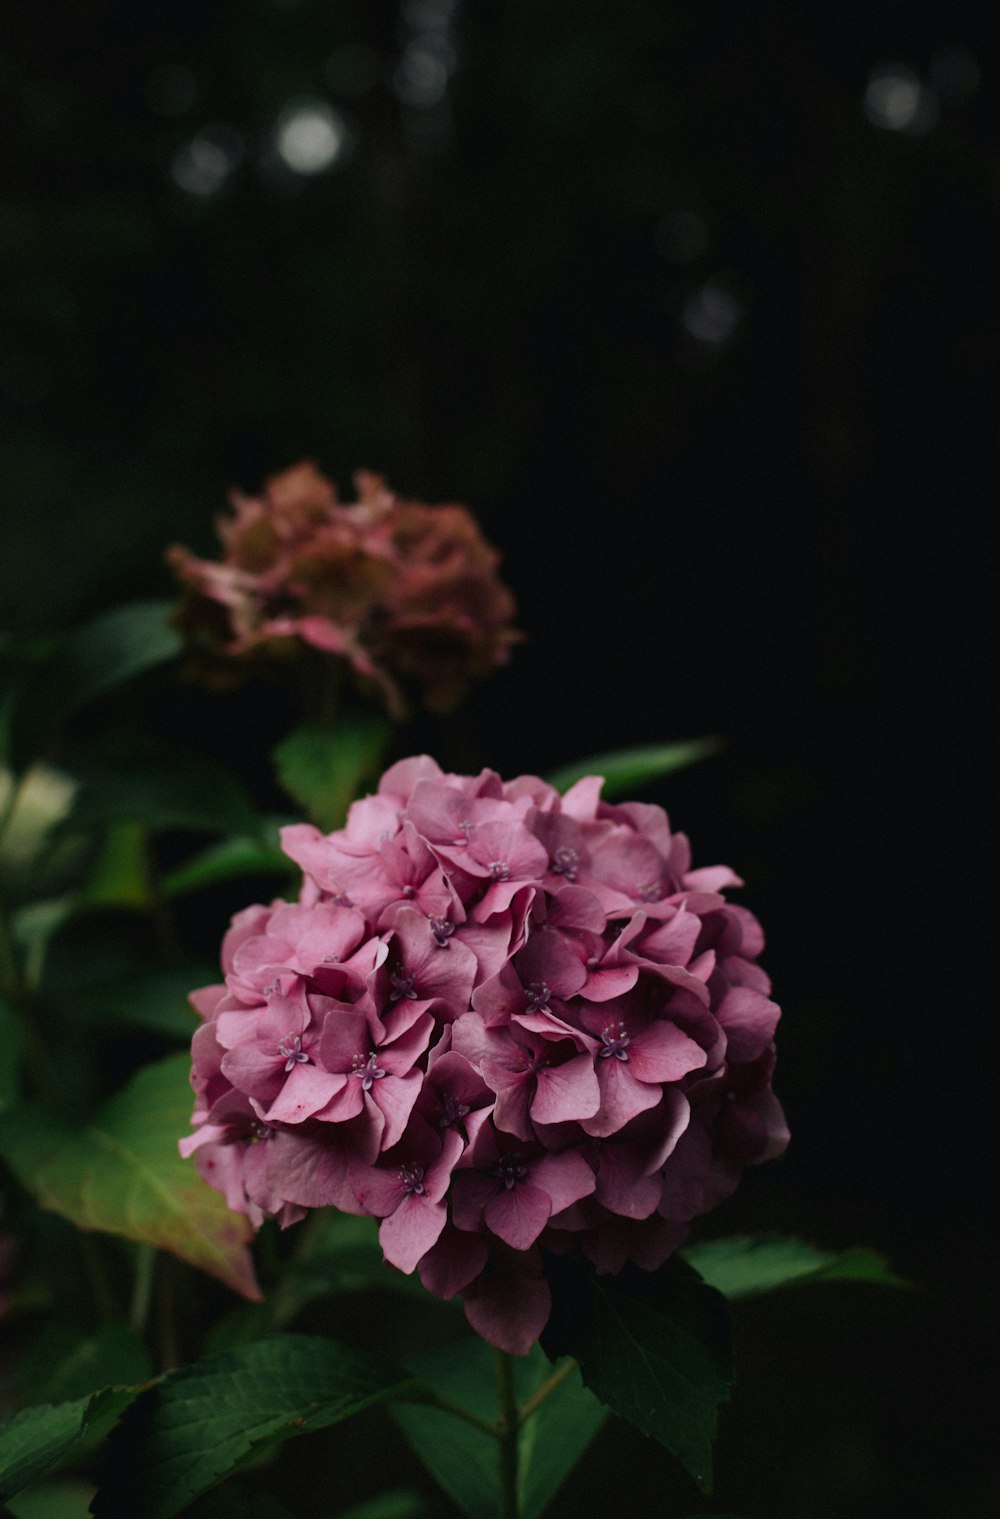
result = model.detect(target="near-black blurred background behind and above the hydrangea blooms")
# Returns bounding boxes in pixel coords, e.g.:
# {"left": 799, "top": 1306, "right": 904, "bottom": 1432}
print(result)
{"left": 0, "top": 0, "right": 1000, "bottom": 1519}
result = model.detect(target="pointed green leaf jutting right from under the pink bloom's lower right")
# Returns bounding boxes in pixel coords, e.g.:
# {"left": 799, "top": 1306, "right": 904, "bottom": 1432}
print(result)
{"left": 682, "top": 1235, "right": 909, "bottom": 1300}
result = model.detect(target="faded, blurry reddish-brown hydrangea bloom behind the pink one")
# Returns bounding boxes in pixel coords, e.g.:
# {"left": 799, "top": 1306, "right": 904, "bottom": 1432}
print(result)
{"left": 167, "top": 463, "right": 518, "bottom": 717}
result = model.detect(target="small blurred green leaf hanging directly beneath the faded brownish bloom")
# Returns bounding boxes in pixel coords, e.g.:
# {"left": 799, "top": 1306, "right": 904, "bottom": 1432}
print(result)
{"left": 272, "top": 714, "right": 392, "bottom": 831}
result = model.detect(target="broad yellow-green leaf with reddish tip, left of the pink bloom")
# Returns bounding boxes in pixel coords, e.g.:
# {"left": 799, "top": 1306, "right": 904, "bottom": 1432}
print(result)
{"left": 0, "top": 1054, "right": 260, "bottom": 1297}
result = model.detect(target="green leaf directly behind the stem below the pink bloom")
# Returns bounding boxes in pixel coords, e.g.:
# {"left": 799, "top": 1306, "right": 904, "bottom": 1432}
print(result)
{"left": 392, "top": 1338, "right": 606, "bottom": 1519}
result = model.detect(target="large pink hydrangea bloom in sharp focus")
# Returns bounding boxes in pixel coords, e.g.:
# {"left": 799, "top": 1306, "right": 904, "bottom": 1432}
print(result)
{"left": 181, "top": 756, "right": 787, "bottom": 1353}
